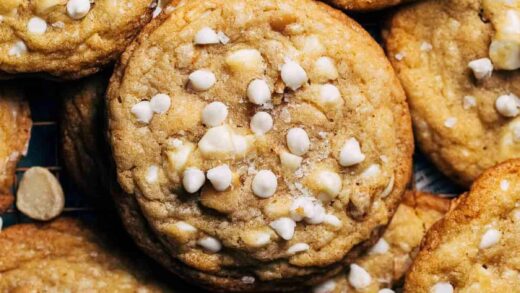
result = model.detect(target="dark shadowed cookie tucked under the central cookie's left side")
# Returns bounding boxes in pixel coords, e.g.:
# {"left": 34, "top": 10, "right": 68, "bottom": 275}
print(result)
{"left": 59, "top": 71, "right": 113, "bottom": 209}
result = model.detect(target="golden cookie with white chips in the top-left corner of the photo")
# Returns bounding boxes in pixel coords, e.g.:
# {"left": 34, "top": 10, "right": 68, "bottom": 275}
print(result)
{"left": 0, "top": 0, "right": 156, "bottom": 79}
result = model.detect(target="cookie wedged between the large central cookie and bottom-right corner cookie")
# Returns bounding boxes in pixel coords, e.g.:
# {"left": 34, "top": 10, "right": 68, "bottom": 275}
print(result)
{"left": 312, "top": 191, "right": 451, "bottom": 293}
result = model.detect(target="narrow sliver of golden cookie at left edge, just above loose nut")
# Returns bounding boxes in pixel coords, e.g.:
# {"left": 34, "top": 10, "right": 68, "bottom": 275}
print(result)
{"left": 0, "top": 84, "right": 32, "bottom": 214}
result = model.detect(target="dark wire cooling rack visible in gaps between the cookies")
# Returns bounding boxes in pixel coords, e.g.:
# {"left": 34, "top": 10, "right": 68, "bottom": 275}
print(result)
{"left": 0, "top": 10, "right": 462, "bottom": 227}
